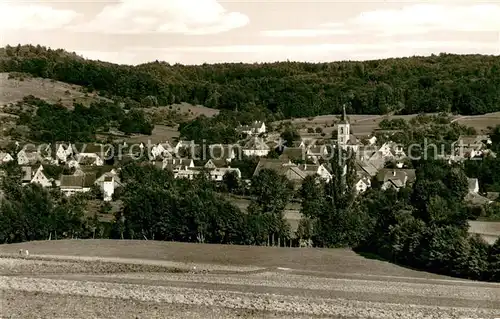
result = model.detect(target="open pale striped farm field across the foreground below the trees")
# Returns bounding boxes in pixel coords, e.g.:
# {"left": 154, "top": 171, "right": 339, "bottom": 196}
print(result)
{"left": 0, "top": 240, "right": 500, "bottom": 319}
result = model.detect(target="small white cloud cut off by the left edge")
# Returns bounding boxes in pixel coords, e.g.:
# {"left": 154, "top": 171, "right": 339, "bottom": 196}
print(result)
{"left": 0, "top": 2, "right": 80, "bottom": 31}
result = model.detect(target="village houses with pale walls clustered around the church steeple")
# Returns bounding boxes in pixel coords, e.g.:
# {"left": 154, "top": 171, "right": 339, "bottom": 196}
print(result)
{"left": 0, "top": 108, "right": 498, "bottom": 212}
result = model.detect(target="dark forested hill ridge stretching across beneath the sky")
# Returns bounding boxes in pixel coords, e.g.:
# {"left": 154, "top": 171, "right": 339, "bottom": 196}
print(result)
{"left": 0, "top": 46, "right": 500, "bottom": 118}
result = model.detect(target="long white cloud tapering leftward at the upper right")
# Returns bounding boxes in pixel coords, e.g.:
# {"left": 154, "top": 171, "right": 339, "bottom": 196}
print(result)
{"left": 262, "top": 4, "right": 500, "bottom": 37}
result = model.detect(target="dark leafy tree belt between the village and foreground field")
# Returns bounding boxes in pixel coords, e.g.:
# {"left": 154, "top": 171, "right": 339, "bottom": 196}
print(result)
{"left": 0, "top": 148, "right": 500, "bottom": 281}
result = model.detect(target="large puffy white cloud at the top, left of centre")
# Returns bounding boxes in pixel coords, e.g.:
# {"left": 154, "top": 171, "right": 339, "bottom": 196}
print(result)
{"left": 71, "top": 0, "right": 249, "bottom": 35}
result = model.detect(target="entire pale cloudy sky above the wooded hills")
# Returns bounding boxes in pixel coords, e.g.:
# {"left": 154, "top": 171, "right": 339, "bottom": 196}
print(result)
{"left": 0, "top": 0, "right": 500, "bottom": 65}
